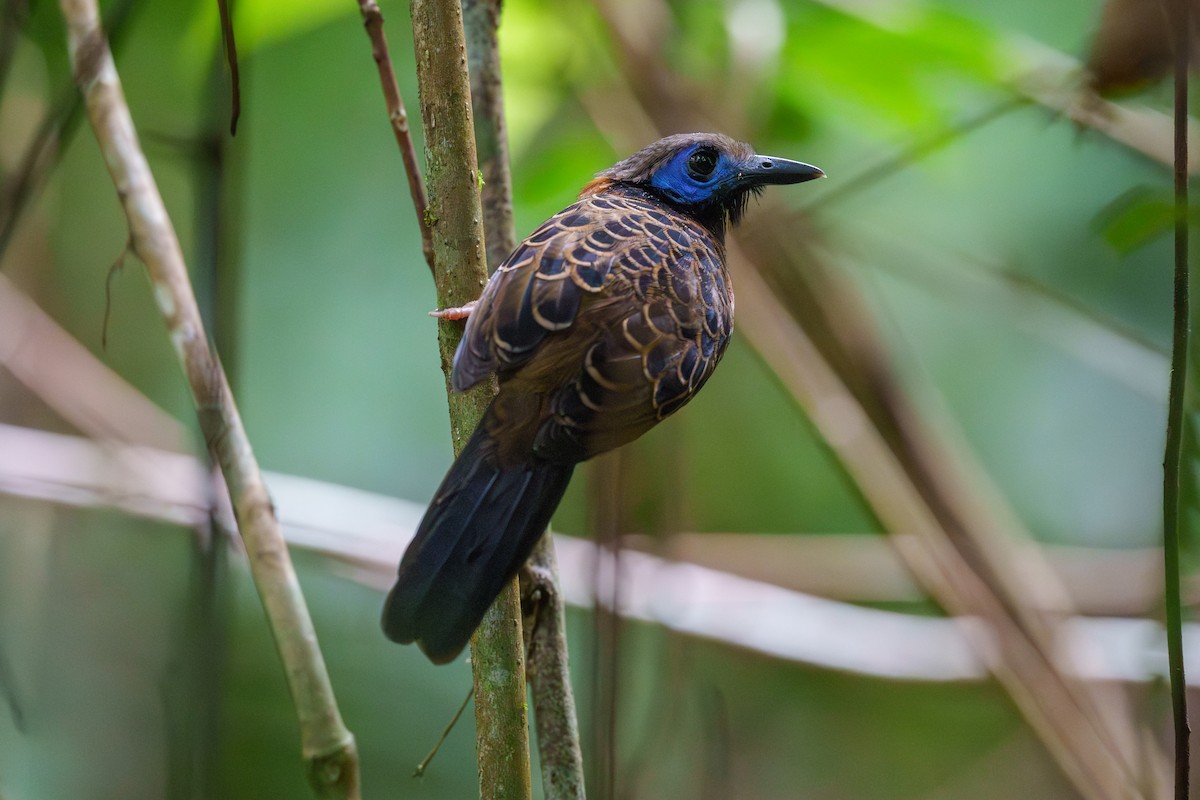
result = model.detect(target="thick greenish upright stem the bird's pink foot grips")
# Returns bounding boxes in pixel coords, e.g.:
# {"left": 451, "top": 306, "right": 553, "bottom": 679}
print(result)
{"left": 410, "top": 0, "right": 532, "bottom": 798}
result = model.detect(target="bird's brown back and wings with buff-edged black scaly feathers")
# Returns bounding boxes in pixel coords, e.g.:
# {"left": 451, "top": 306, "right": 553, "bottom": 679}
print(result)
{"left": 454, "top": 194, "right": 733, "bottom": 463}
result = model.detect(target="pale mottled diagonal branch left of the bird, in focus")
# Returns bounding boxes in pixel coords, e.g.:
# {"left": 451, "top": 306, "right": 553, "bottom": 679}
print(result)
{"left": 60, "top": 0, "right": 359, "bottom": 799}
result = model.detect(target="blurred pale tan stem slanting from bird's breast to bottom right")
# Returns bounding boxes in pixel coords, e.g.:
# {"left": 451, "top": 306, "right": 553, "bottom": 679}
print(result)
{"left": 736, "top": 257, "right": 1140, "bottom": 800}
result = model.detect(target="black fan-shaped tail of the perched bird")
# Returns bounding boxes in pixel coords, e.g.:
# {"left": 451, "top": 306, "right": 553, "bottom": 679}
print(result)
{"left": 383, "top": 425, "right": 575, "bottom": 663}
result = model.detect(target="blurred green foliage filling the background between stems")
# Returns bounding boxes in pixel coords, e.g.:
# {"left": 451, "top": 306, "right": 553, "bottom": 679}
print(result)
{"left": 0, "top": 0, "right": 1194, "bottom": 799}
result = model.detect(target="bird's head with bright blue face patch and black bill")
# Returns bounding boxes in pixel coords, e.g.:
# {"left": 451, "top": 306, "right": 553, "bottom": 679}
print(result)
{"left": 584, "top": 133, "right": 824, "bottom": 230}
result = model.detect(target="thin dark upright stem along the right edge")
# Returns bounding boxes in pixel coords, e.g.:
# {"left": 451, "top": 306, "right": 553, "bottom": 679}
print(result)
{"left": 1163, "top": 0, "right": 1192, "bottom": 800}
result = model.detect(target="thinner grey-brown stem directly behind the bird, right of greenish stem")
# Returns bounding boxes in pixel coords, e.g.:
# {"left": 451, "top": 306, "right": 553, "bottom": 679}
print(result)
{"left": 462, "top": 0, "right": 584, "bottom": 800}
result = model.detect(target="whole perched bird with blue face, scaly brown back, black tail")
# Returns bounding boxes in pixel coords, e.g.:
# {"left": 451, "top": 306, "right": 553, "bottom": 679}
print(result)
{"left": 382, "top": 133, "right": 824, "bottom": 663}
